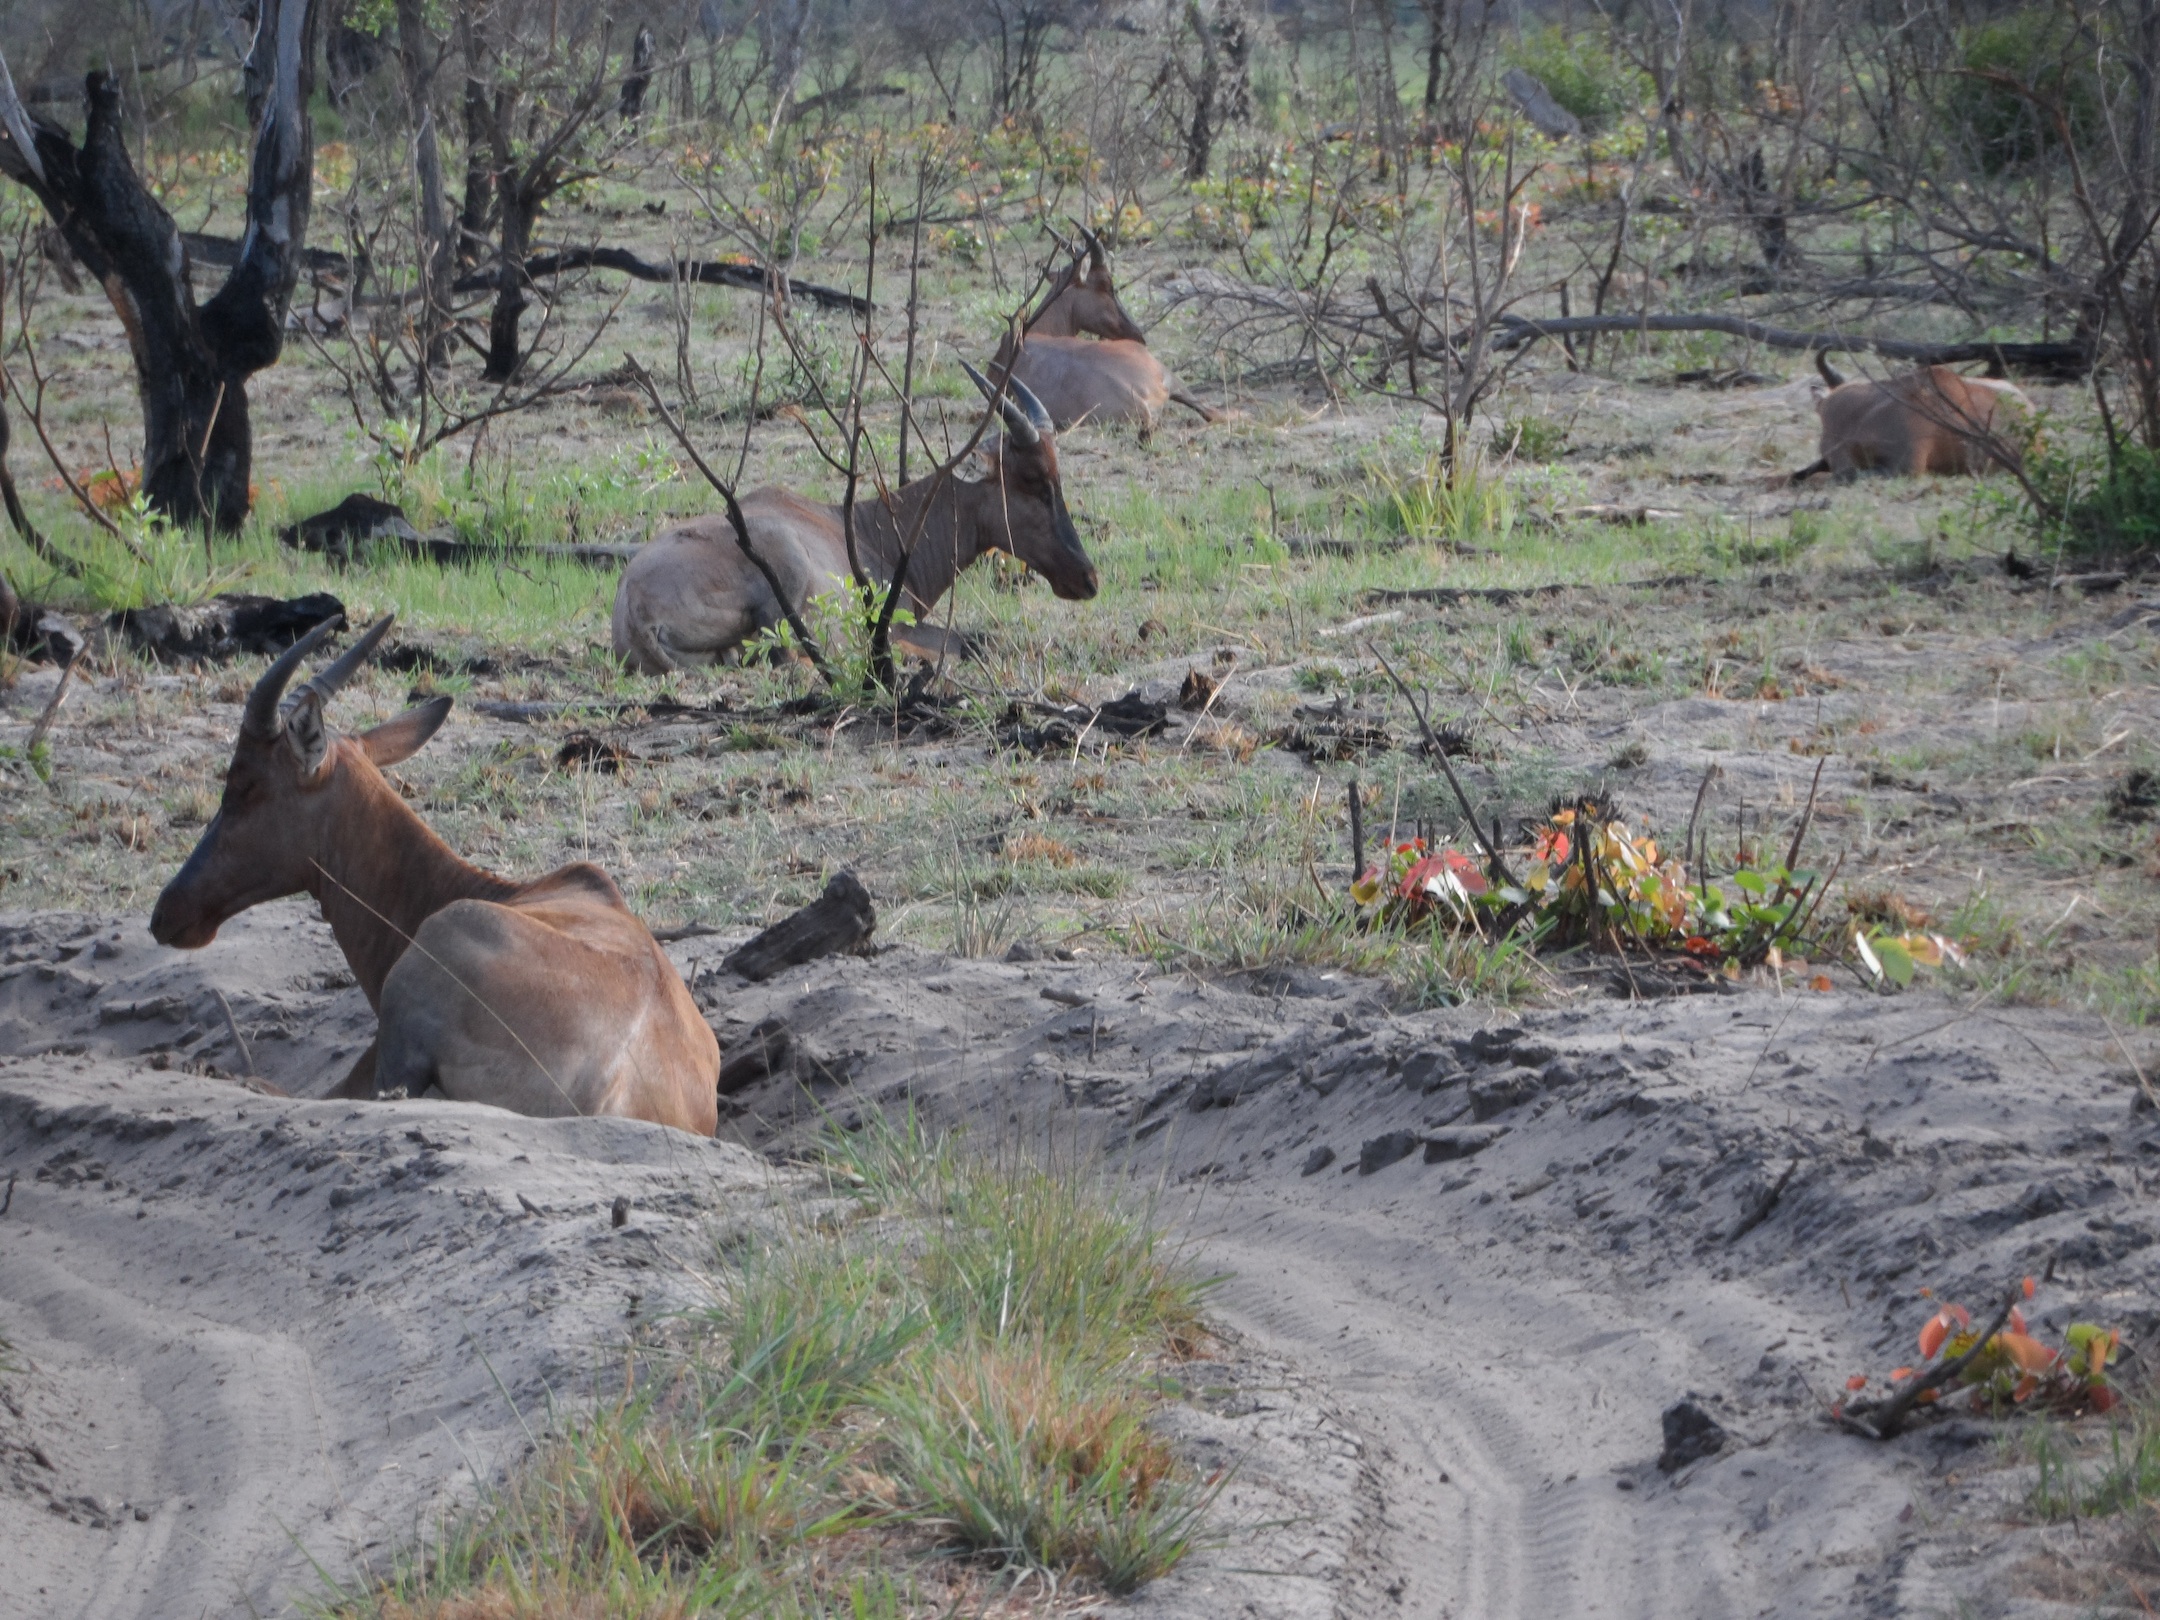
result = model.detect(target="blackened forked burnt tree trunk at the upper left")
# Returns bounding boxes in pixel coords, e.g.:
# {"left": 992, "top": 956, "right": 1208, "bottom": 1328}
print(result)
{"left": 0, "top": 0, "right": 315, "bottom": 531}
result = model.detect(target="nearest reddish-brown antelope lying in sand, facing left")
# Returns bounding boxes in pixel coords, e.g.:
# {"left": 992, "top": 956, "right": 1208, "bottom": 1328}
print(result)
{"left": 149, "top": 618, "right": 719, "bottom": 1136}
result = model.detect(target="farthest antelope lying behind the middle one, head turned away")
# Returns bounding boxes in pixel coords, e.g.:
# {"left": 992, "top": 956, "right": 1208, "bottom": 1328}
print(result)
{"left": 991, "top": 231, "right": 1223, "bottom": 436}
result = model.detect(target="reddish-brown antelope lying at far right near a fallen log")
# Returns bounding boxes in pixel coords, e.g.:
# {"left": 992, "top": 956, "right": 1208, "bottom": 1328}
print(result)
{"left": 1791, "top": 350, "right": 2033, "bottom": 484}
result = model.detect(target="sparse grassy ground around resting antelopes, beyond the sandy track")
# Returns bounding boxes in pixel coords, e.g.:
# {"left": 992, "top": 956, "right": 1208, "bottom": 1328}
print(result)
{"left": 0, "top": 149, "right": 2160, "bottom": 1024}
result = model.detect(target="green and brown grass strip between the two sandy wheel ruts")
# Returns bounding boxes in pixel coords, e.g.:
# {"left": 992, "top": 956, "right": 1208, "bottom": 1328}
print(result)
{"left": 320, "top": 1119, "right": 1218, "bottom": 1620}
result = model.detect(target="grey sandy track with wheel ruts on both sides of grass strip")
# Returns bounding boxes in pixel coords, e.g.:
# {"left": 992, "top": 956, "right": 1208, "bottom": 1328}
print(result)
{"left": 0, "top": 903, "right": 2160, "bottom": 1616}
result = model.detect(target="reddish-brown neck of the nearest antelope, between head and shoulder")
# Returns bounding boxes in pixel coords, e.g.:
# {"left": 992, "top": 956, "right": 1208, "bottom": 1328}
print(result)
{"left": 307, "top": 745, "right": 518, "bottom": 1007}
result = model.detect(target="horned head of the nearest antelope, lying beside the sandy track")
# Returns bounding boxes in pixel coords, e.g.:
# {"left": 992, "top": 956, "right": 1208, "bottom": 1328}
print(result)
{"left": 149, "top": 616, "right": 449, "bottom": 950}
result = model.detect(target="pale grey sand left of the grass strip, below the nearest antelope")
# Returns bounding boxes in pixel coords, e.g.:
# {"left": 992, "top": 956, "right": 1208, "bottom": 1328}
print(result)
{"left": 0, "top": 907, "right": 794, "bottom": 1620}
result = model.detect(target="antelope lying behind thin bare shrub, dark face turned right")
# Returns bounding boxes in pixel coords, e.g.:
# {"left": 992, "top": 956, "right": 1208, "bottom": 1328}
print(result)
{"left": 613, "top": 365, "right": 1099, "bottom": 674}
